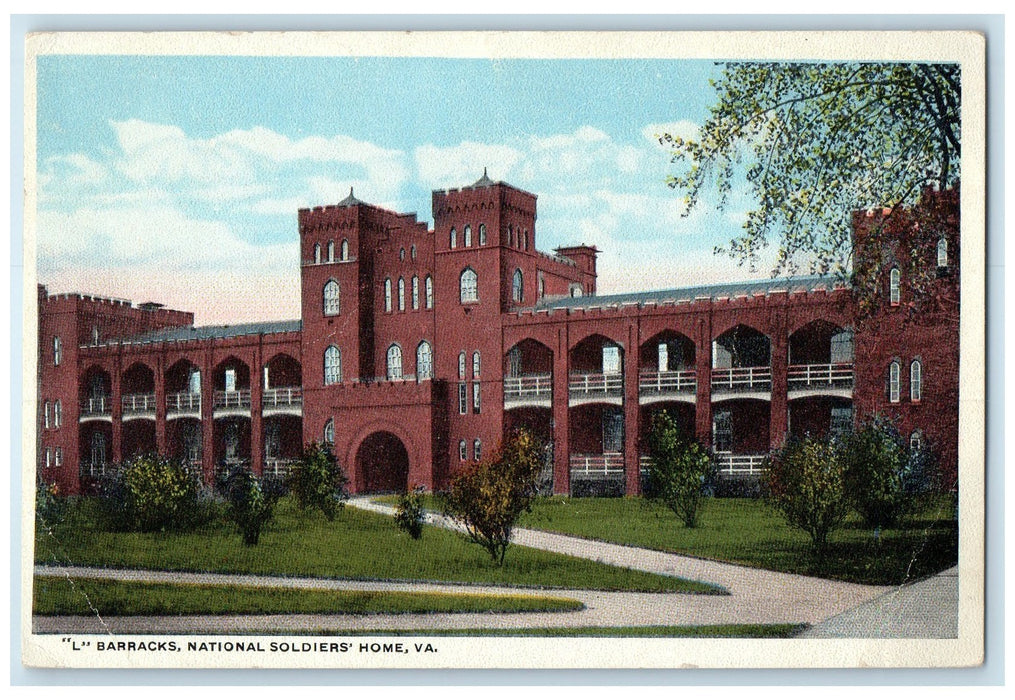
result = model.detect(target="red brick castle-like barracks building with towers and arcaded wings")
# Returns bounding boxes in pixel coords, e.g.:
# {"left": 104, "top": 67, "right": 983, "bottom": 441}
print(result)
{"left": 38, "top": 173, "right": 959, "bottom": 494}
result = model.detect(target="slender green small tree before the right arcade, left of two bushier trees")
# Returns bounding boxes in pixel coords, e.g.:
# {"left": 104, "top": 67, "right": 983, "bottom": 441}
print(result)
{"left": 647, "top": 412, "right": 713, "bottom": 528}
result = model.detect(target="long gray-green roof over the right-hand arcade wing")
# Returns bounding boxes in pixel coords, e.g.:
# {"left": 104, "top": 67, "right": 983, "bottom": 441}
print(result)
{"left": 535, "top": 276, "right": 849, "bottom": 309}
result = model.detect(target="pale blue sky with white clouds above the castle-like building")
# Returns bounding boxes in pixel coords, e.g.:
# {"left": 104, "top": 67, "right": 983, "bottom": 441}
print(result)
{"left": 38, "top": 56, "right": 767, "bottom": 323}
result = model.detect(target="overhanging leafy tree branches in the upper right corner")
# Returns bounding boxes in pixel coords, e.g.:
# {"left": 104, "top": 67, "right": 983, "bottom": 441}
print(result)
{"left": 660, "top": 62, "right": 961, "bottom": 284}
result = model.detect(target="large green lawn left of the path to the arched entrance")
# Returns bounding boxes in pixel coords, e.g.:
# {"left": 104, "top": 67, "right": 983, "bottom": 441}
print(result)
{"left": 35, "top": 498, "right": 722, "bottom": 593}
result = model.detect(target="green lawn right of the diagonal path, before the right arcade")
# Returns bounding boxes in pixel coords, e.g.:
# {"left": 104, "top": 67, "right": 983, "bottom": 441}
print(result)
{"left": 519, "top": 496, "right": 958, "bottom": 585}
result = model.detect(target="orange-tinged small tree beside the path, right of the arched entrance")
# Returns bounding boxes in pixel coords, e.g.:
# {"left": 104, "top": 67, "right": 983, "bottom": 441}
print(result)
{"left": 443, "top": 430, "right": 542, "bottom": 566}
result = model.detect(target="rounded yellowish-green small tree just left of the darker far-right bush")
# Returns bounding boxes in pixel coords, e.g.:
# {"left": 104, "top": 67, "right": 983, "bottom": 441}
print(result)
{"left": 764, "top": 437, "right": 850, "bottom": 552}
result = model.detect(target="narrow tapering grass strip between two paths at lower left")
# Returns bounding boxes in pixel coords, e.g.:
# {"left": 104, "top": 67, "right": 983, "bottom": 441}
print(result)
{"left": 32, "top": 576, "right": 584, "bottom": 616}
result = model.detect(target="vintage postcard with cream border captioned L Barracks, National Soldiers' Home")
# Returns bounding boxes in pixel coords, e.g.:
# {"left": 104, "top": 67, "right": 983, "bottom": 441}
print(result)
{"left": 20, "top": 31, "right": 985, "bottom": 669}
